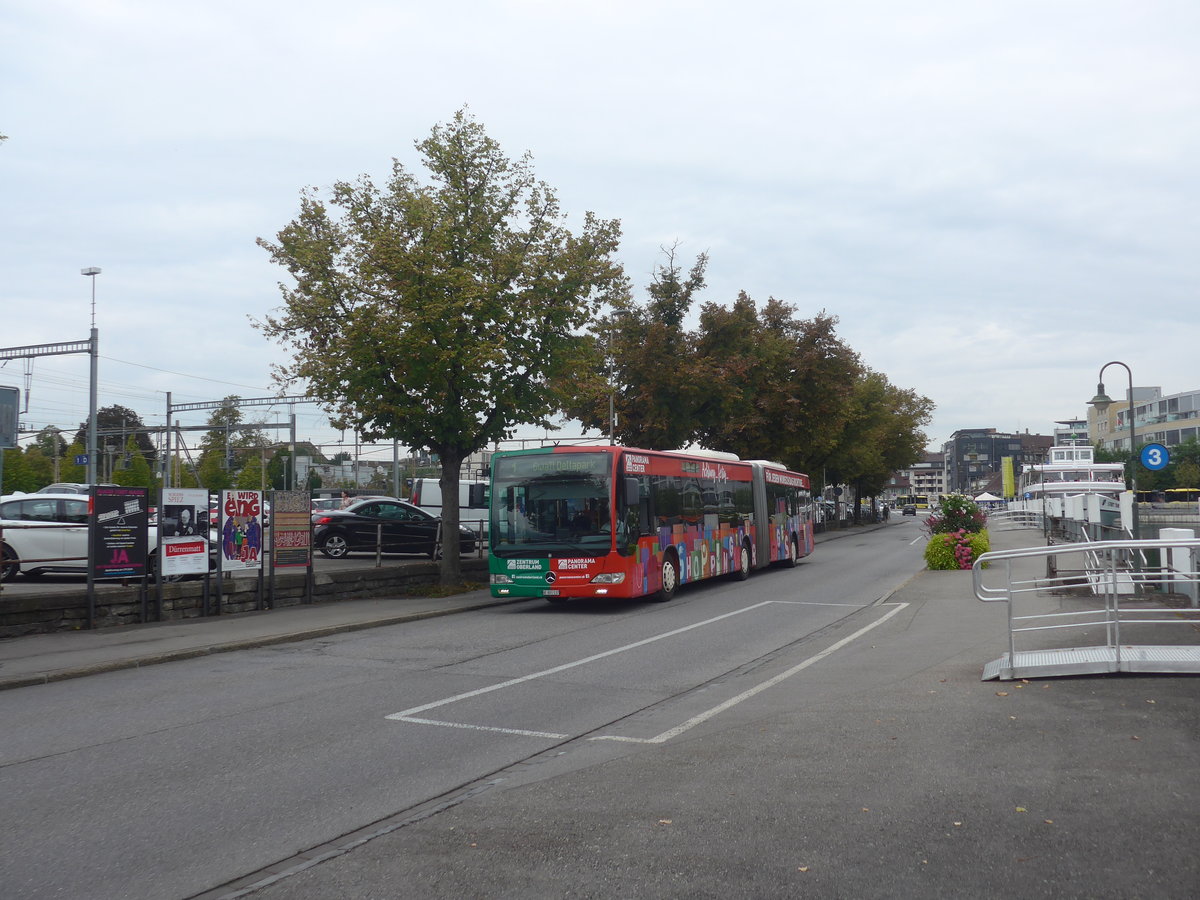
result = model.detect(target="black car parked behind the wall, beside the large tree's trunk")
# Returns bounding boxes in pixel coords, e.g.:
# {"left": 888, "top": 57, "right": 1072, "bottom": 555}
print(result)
{"left": 312, "top": 498, "right": 475, "bottom": 559}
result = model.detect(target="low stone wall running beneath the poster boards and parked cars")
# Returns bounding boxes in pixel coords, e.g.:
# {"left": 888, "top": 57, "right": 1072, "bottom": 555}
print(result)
{"left": 0, "top": 559, "right": 487, "bottom": 637}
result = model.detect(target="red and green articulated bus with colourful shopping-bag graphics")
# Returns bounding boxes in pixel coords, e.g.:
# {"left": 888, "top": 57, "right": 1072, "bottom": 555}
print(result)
{"left": 488, "top": 445, "right": 812, "bottom": 601}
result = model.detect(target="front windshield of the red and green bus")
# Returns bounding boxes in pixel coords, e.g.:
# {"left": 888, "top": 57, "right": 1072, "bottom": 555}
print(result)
{"left": 490, "top": 451, "right": 612, "bottom": 557}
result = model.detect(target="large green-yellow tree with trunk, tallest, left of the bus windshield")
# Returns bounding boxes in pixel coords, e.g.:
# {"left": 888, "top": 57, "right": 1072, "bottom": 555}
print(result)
{"left": 257, "top": 110, "right": 626, "bottom": 583}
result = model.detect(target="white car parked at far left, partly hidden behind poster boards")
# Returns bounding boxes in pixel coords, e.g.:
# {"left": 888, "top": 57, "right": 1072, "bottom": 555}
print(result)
{"left": 0, "top": 492, "right": 216, "bottom": 581}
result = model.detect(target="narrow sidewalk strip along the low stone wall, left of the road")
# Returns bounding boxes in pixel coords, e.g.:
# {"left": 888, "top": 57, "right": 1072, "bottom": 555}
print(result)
{"left": 0, "top": 524, "right": 887, "bottom": 690}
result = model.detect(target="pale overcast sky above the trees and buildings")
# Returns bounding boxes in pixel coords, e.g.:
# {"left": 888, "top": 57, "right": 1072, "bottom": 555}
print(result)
{"left": 0, "top": 0, "right": 1200, "bottom": 458}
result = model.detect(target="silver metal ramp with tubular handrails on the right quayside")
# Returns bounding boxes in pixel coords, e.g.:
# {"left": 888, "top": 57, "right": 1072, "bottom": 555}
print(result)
{"left": 972, "top": 539, "right": 1200, "bottom": 682}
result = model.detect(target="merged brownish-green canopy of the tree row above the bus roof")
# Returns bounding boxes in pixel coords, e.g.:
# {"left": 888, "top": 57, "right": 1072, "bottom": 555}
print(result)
{"left": 564, "top": 247, "right": 932, "bottom": 492}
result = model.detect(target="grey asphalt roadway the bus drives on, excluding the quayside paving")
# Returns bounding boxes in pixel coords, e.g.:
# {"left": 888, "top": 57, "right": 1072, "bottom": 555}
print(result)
{"left": 0, "top": 520, "right": 917, "bottom": 898}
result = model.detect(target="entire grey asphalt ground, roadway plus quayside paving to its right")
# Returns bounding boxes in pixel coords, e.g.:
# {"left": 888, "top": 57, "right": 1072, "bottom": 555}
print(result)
{"left": 0, "top": 520, "right": 1200, "bottom": 900}
